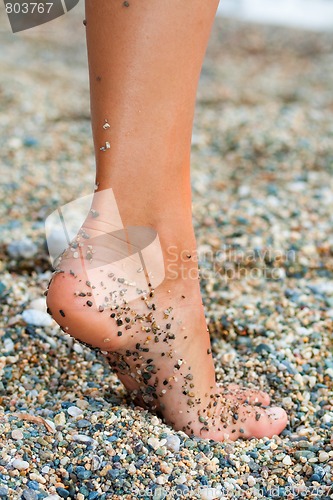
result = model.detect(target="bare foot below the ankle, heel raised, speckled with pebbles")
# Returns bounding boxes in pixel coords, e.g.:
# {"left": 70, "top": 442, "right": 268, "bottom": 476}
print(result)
{"left": 47, "top": 218, "right": 287, "bottom": 441}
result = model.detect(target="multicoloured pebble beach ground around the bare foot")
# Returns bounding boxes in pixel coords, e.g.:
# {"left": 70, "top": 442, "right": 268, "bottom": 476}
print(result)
{"left": 0, "top": 6, "right": 333, "bottom": 500}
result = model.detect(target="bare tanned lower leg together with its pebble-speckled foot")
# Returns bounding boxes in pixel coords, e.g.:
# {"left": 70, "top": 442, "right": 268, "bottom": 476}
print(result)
{"left": 48, "top": 0, "right": 286, "bottom": 440}
